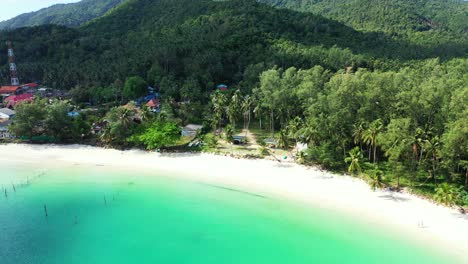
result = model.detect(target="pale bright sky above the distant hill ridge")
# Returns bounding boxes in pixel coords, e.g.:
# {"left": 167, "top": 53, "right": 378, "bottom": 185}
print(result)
{"left": 0, "top": 0, "right": 80, "bottom": 21}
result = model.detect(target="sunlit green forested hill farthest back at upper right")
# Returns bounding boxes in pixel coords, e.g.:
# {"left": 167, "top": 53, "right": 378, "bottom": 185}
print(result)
{"left": 259, "top": 0, "right": 468, "bottom": 34}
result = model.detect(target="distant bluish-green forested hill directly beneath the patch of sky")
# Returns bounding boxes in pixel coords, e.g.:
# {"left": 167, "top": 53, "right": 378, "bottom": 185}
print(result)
{"left": 0, "top": 0, "right": 125, "bottom": 30}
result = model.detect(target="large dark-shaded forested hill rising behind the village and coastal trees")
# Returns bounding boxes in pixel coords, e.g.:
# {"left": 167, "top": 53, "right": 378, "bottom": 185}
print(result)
{"left": 0, "top": 0, "right": 468, "bottom": 89}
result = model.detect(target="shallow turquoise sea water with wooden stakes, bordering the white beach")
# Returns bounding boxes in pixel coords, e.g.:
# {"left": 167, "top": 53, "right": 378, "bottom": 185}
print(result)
{"left": 0, "top": 161, "right": 456, "bottom": 264}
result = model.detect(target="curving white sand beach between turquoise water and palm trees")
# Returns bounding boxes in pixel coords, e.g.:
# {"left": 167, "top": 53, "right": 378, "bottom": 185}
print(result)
{"left": 0, "top": 144, "right": 468, "bottom": 261}
